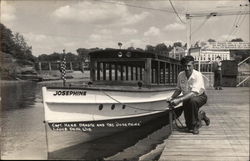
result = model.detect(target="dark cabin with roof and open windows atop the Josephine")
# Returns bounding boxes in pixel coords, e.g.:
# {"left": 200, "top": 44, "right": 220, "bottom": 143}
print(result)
{"left": 89, "top": 49, "right": 181, "bottom": 86}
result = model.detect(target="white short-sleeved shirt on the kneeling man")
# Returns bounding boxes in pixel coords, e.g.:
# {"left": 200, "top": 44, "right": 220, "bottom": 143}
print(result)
{"left": 177, "top": 69, "right": 205, "bottom": 95}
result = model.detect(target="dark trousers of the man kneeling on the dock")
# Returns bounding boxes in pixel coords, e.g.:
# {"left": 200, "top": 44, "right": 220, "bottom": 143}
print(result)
{"left": 183, "top": 93, "right": 207, "bottom": 129}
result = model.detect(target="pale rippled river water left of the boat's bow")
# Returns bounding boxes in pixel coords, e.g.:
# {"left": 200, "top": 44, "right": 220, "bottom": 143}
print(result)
{"left": 1, "top": 82, "right": 47, "bottom": 159}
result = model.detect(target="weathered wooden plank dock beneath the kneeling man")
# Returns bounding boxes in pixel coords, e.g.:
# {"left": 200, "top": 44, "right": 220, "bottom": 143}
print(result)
{"left": 159, "top": 87, "right": 250, "bottom": 161}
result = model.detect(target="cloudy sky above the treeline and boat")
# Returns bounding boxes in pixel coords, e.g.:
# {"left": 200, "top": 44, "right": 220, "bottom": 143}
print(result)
{"left": 0, "top": 0, "right": 249, "bottom": 56}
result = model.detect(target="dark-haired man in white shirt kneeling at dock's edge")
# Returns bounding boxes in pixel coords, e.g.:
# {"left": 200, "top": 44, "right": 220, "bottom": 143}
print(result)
{"left": 167, "top": 55, "right": 210, "bottom": 134}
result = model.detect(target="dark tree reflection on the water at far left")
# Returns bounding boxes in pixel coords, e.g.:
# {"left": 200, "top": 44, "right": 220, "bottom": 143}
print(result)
{"left": 1, "top": 82, "right": 37, "bottom": 110}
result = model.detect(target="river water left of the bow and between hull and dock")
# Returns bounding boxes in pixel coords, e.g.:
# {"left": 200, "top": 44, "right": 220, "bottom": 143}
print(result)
{"left": 0, "top": 82, "right": 174, "bottom": 160}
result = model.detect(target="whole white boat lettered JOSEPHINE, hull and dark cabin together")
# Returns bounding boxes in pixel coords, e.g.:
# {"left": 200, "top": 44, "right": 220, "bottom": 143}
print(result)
{"left": 42, "top": 50, "right": 184, "bottom": 159}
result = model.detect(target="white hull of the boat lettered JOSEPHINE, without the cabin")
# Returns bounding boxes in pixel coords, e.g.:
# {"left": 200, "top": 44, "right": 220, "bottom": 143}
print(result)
{"left": 43, "top": 87, "right": 184, "bottom": 159}
